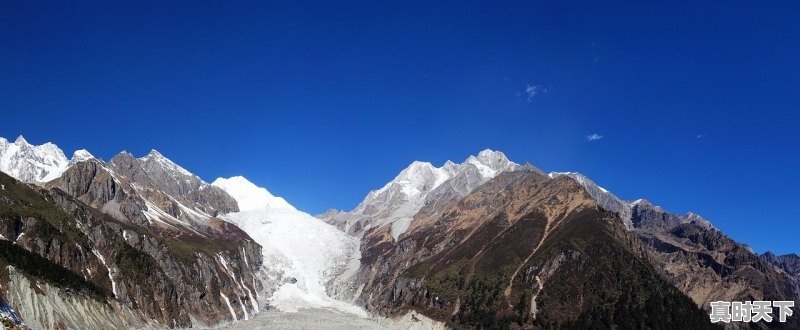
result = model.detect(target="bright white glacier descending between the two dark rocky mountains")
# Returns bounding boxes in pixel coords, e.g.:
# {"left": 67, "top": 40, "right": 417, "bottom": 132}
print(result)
{"left": 213, "top": 177, "right": 367, "bottom": 317}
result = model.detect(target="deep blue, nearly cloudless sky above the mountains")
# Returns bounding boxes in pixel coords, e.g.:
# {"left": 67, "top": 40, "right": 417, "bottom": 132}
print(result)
{"left": 0, "top": 1, "right": 800, "bottom": 253}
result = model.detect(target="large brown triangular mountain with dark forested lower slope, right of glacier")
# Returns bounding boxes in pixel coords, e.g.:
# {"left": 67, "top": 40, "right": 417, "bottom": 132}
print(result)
{"left": 340, "top": 170, "right": 711, "bottom": 328}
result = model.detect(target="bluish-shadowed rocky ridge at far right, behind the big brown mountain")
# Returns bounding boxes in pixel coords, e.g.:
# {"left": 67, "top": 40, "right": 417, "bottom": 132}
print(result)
{"left": 632, "top": 201, "right": 798, "bottom": 308}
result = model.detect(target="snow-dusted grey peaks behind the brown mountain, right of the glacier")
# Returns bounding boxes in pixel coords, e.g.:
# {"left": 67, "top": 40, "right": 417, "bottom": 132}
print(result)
{"left": 320, "top": 149, "right": 519, "bottom": 239}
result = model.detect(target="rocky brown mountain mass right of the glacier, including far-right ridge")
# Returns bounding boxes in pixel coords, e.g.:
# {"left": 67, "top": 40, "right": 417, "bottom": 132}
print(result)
{"left": 328, "top": 151, "right": 800, "bottom": 327}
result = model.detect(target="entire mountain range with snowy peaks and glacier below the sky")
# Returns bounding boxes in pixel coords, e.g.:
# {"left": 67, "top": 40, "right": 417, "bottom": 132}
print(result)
{"left": 0, "top": 137, "right": 800, "bottom": 329}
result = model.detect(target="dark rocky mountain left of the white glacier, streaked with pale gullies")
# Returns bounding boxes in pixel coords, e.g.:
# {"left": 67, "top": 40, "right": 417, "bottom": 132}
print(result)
{"left": 0, "top": 153, "right": 262, "bottom": 328}
